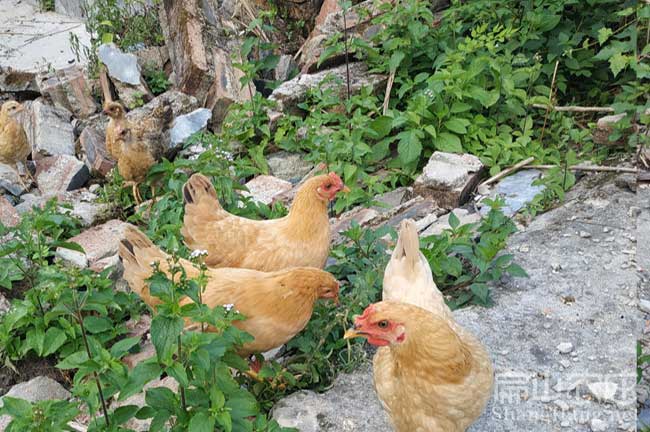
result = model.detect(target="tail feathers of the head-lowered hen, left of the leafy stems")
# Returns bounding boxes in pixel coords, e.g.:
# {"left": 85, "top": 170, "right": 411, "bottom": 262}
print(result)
{"left": 119, "top": 226, "right": 167, "bottom": 306}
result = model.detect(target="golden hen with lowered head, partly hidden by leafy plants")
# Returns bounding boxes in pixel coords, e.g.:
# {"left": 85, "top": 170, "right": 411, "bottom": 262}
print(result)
{"left": 119, "top": 227, "right": 339, "bottom": 356}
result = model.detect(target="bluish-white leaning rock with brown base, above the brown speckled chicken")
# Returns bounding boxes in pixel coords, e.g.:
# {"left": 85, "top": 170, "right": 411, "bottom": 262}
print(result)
{"left": 97, "top": 43, "right": 153, "bottom": 108}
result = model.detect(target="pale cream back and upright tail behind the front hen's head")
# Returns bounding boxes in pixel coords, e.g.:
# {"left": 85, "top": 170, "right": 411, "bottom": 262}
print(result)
{"left": 382, "top": 219, "right": 453, "bottom": 319}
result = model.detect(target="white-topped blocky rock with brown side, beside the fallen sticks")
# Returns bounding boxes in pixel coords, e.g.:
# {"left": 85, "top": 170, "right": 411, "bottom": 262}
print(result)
{"left": 413, "top": 151, "right": 483, "bottom": 209}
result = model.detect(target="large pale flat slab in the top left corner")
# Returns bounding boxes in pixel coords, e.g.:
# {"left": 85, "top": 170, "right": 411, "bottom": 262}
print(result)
{"left": 0, "top": 0, "right": 91, "bottom": 73}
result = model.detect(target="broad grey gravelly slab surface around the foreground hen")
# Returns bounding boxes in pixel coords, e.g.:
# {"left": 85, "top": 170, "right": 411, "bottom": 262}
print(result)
{"left": 273, "top": 175, "right": 636, "bottom": 432}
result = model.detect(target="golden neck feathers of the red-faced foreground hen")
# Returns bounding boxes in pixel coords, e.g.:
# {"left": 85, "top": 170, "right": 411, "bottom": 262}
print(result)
{"left": 382, "top": 320, "right": 473, "bottom": 384}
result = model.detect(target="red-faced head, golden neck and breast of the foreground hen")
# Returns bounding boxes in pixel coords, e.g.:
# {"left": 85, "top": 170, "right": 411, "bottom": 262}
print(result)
{"left": 344, "top": 301, "right": 493, "bottom": 432}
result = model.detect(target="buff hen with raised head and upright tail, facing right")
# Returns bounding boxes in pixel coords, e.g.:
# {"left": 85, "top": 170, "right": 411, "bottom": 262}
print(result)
{"left": 181, "top": 172, "right": 349, "bottom": 271}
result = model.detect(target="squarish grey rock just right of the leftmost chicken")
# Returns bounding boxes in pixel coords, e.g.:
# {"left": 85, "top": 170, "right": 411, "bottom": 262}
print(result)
{"left": 23, "top": 99, "right": 75, "bottom": 160}
